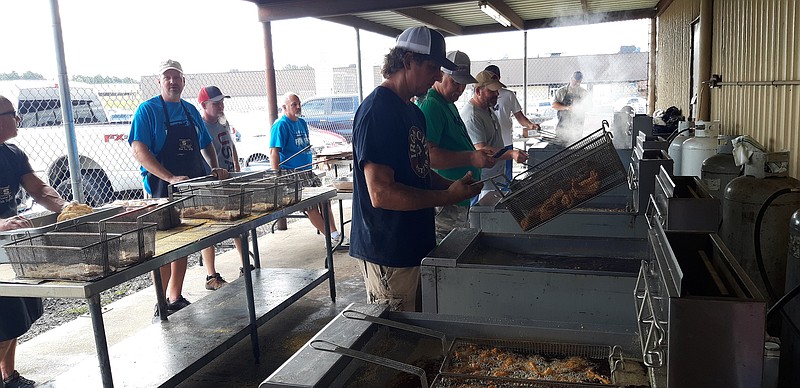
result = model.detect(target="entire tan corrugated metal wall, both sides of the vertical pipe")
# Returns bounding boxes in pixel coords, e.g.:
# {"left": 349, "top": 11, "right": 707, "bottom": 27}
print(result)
{"left": 656, "top": 0, "right": 800, "bottom": 178}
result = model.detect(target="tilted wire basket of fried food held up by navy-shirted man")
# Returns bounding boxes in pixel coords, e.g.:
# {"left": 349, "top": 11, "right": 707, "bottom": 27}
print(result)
{"left": 499, "top": 121, "right": 627, "bottom": 231}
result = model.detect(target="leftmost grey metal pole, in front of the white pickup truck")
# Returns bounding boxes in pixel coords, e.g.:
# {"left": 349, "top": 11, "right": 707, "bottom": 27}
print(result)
{"left": 50, "top": 0, "right": 84, "bottom": 203}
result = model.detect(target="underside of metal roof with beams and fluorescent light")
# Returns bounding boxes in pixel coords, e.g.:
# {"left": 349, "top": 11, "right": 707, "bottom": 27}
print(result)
{"left": 247, "top": 0, "right": 671, "bottom": 37}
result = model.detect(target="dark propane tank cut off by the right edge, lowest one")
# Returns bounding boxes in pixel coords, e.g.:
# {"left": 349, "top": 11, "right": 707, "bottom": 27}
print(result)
{"left": 778, "top": 210, "right": 800, "bottom": 387}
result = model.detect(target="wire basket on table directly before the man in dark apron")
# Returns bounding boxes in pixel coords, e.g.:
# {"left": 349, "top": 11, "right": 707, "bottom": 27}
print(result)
{"left": 175, "top": 187, "right": 253, "bottom": 221}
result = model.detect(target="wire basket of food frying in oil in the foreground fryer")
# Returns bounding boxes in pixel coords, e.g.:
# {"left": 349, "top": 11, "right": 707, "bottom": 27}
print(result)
{"left": 441, "top": 338, "right": 613, "bottom": 386}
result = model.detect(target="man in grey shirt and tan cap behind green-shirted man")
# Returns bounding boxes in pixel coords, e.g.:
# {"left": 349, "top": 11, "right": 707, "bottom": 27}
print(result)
{"left": 459, "top": 70, "right": 528, "bottom": 200}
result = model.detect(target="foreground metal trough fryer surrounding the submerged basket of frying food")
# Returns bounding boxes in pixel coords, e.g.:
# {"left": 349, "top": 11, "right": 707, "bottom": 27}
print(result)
{"left": 259, "top": 304, "right": 638, "bottom": 388}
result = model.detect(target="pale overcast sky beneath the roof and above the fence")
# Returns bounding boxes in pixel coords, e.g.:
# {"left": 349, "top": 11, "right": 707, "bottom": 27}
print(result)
{"left": 0, "top": 0, "right": 649, "bottom": 79}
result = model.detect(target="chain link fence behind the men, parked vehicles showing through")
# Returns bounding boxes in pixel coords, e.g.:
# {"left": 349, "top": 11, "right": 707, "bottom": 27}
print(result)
{"left": 0, "top": 21, "right": 648, "bottom": 212}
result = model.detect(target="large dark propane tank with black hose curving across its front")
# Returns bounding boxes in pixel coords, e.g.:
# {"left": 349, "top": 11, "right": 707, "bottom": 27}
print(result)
{"left": 720, "top": 175, "right": 800, "bottom": 304}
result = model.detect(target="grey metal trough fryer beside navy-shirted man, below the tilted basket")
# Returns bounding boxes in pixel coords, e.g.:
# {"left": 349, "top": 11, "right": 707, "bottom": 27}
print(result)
{"left": 420, "top": 228, "right": 648, "bottom": 332}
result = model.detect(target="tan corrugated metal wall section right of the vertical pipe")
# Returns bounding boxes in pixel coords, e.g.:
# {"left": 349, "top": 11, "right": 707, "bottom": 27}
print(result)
{"left": 711, "top": 0, "right": 800, "bottom": 177}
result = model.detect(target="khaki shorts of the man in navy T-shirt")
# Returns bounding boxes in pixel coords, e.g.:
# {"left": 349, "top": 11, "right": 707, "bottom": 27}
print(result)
{"left": 360, "top": 260, "right": 422, "bottom": 311}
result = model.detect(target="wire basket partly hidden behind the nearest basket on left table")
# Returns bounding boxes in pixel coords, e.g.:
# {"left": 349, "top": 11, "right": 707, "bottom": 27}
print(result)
{"left": 58, "top": 221, "right": 157, "bottom": 267}
